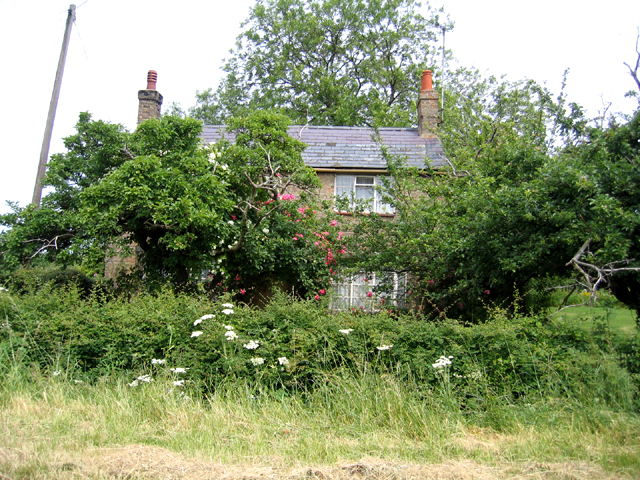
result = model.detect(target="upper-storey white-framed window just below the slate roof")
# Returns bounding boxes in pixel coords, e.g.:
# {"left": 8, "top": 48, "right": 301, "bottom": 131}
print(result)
{"left": 335, "top": 175, "right": 395, "bottom": 214}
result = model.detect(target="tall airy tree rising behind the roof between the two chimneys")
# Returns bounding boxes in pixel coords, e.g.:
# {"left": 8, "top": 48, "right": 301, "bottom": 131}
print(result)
{"left": 191, "top": 0, "right": 448, "bottom": 126}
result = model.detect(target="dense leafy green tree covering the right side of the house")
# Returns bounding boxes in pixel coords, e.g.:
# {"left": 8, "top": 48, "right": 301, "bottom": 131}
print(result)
{"left": 350, "top": 71, "right": 639, "bottom": 320}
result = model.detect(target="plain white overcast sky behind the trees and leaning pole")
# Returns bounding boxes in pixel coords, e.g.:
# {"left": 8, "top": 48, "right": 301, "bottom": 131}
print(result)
{"left": 0, "top": 0, "right": 640, "bottom": 212}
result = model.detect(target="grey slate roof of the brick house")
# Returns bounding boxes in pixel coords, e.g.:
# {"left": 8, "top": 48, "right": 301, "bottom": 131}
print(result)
{"left": 202, "top": 125, "right": 445, "bottom": 169}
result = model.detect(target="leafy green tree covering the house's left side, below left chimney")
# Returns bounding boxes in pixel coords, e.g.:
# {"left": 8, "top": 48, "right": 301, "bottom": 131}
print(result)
{"left": 0, "top": 112, "right": 342, "bottom": 293}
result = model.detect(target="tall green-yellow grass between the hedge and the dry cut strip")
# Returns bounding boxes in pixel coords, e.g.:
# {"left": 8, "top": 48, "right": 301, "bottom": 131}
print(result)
{"left": 0, "top": 366, "right": 640, "bottom": 479}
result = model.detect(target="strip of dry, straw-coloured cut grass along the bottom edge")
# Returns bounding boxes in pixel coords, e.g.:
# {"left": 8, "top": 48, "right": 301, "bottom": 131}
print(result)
{"left": 0, "top": 445, "right": 631, "bottom": 480}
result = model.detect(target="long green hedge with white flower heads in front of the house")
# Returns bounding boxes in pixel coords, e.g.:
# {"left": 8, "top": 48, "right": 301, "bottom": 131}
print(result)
{"left": 0, "top": 287, "right": 640, "bottom": 410}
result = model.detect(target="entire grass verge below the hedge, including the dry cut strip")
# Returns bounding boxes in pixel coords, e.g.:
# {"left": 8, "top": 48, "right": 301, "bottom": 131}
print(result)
{"left": 0, "top": 372, "right": 640, "bottom": 480}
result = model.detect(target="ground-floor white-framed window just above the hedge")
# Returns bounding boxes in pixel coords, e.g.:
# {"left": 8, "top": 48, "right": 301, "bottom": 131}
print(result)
{"left": 330, "top": 272, "right": 407, "bottom": 311}
